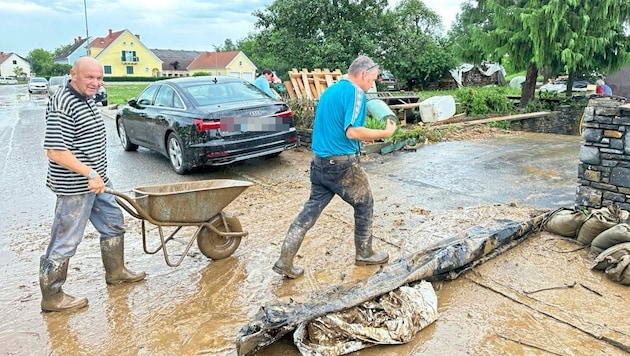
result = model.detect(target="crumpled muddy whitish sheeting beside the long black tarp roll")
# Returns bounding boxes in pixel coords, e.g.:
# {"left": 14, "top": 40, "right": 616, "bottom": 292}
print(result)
{"left": 293, "top": 281, "right": 438, "bottom": 356}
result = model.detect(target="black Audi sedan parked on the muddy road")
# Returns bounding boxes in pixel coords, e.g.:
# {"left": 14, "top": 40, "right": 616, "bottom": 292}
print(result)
{"left": 116, "top": 76, "right": 298, "bottom": 174}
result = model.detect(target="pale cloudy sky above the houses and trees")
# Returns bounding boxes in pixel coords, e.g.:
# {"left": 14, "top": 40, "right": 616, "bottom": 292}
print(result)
{"left": 0, "top": 0, "right": 462, "bottom": 57}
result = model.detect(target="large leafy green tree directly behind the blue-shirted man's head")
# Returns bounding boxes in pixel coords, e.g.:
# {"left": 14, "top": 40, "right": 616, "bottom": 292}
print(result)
{"left": 254, "top": 0, "right": 396, "bottom": 71}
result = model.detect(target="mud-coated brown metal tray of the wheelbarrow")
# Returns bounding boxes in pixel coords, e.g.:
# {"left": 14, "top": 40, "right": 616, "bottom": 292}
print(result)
{"left": 133, "top": 179, "right": 253, "bottom": 223}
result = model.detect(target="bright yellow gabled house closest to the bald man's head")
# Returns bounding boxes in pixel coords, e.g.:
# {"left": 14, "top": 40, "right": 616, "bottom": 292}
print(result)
{"left": 89, "top": 29, "right": 162, "bottom": 77}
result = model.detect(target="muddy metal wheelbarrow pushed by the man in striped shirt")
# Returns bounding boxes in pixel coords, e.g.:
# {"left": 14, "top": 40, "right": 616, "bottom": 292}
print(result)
{"left": 105, "top": 179, "right": 253, "bottom": 267}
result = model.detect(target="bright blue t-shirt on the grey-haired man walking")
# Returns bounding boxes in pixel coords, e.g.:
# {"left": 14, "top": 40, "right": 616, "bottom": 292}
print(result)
{"left": 311, "top": 79, "right": 366, "bottom": 157}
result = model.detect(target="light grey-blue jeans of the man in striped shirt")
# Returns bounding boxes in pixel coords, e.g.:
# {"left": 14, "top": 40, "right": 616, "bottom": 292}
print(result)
{"left": 45, "top": 184, "right": 125, "bottom": 259}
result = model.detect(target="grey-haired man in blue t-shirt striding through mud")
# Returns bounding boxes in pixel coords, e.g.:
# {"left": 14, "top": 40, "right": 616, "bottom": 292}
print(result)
{"left": 273, "top": 56, "right": 396, "bottom": 278}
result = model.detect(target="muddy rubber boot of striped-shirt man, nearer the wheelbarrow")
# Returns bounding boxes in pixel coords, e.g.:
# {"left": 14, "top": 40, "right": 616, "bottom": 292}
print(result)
{"left": 101, "top": 235, "right": 147, "bottom": 284}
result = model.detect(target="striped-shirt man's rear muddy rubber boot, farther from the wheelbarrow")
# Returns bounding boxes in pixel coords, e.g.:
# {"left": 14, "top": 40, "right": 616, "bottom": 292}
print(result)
{"left": 39, "top": 256, "right": 87, "bottom": 312}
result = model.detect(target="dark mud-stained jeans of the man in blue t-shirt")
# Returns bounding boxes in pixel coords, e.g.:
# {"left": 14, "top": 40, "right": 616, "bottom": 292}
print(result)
{"left": 293, "top": 156, "right": 374, "bottom": 236}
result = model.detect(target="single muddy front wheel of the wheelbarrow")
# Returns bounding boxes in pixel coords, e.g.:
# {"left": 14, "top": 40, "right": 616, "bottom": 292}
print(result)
{"left": 197, "top": 216, "right": 243, "bottom": 260}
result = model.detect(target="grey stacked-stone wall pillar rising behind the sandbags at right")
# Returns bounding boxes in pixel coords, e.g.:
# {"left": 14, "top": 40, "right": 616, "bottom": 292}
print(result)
{"left": 576, "top": 98, "right": 630, "bottom": 210}
